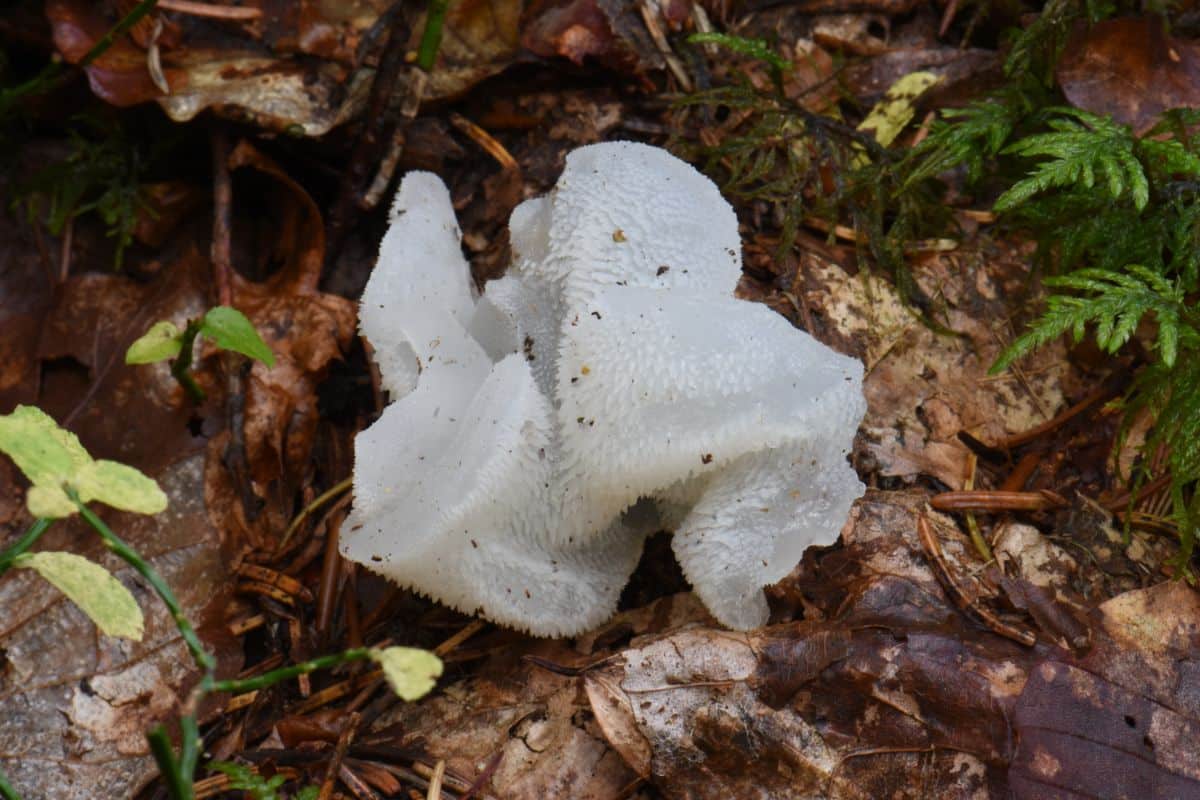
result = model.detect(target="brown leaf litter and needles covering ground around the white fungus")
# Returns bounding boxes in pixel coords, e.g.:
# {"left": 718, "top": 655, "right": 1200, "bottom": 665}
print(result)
{"left": 0, "top": 0, "right": 1200, "bottom": 799}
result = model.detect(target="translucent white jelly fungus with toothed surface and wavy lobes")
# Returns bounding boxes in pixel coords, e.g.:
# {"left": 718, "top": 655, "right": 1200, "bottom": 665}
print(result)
{"left": 341, "top": 142, "right": 865, "bottom": 636}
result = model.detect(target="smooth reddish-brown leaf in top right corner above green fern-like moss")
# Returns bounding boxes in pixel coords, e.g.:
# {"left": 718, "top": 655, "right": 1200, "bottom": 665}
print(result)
{"left": 1057, "top": 16, "right": 1200, "bottom": 134}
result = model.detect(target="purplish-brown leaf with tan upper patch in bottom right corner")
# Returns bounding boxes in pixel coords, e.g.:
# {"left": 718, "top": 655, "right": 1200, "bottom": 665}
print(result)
{"left": 1009, "top": 582, "right": 1200, "bottom": 799}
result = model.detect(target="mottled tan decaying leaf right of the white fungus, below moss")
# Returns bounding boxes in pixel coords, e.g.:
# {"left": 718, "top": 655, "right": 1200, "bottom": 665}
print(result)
{"left": 797, "top": 253, "right": 1073, "bottom": 488}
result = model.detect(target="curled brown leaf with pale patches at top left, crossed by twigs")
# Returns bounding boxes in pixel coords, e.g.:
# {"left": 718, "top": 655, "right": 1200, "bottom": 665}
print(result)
{"left": 46, "top": 0, "right": 521, "bottom": 137}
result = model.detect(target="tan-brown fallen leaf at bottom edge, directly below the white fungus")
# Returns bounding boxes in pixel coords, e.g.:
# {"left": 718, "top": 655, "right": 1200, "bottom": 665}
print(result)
{"left": 360, "top": 594, "right": 712, "bottom": 800}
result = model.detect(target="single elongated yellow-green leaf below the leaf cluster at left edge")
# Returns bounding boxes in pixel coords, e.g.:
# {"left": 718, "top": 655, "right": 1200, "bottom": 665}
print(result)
{"left": 13, "top": 551, "right": 145, "bottom": 642}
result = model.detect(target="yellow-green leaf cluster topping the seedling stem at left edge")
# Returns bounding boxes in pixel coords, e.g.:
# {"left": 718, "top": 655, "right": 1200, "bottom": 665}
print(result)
{"left": 0, "top": 405, "right": 167, "bottom": 519}
